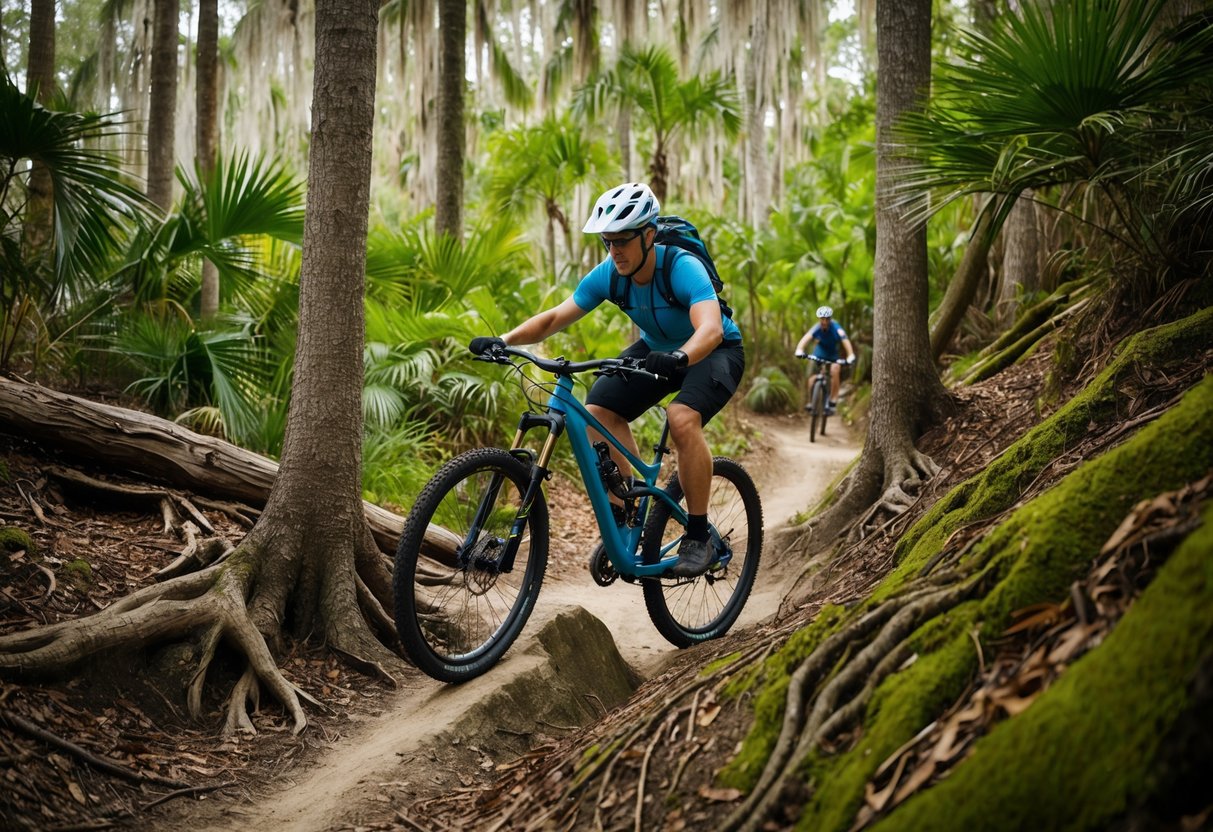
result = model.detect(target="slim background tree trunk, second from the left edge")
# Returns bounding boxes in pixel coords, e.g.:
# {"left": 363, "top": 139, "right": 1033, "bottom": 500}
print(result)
{"left": 148, "top": 0, "right": 181, "bottom": 212}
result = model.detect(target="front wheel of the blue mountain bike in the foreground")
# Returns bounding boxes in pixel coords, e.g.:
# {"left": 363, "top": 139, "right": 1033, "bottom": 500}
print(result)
{"left": 393, "top": 448, "right": 548, "bottom": 682}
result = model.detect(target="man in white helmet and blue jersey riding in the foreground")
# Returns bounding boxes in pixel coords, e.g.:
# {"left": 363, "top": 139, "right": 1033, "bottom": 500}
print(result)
{"left": 468, "top": 182, "right": 745, "bottom": 577}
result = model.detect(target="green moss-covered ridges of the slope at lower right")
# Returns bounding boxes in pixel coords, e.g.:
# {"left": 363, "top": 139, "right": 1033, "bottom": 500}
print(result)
{"left": 721, "top": 309, "right": 1213, "bottom": 830}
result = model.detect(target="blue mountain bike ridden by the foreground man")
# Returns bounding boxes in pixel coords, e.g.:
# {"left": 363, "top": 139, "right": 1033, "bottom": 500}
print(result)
{"left": 393, "top": 347, "right": 763, "bottom": 682}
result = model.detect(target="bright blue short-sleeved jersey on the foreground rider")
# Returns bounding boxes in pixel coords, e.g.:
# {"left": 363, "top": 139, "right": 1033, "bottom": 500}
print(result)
{"left": 573, "top": 245, "right": 741, "bottom": 352}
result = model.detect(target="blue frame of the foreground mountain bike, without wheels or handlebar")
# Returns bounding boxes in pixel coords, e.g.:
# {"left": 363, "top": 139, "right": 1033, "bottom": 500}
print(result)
{"left": 511, "top": 376, "right": 687, "bottom": 577}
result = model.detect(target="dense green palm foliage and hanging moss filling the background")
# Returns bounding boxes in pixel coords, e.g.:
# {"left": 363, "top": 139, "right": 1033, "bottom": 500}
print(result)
{"left": 0, "top": 0, "right": 1213, "bottom": 514}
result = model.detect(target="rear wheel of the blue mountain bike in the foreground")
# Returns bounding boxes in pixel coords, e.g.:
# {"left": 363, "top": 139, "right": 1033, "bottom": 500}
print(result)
{"left": 642, "top": 456, "right": 763, "bottom": 648}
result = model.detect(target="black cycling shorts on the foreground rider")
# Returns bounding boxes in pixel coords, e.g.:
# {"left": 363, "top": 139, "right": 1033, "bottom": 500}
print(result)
{"left": 586, "top": 338, "right": 746, "bottom": 424}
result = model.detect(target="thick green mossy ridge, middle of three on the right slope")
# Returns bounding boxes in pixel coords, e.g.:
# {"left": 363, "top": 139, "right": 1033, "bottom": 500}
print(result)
{"left": 802, "top": 377, "right": 1213, "bottom": 830}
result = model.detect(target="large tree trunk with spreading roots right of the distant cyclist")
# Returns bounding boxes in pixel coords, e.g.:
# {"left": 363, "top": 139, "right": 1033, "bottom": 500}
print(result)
{"left": 816, "top": 0, "right": 949, "bottom": 540}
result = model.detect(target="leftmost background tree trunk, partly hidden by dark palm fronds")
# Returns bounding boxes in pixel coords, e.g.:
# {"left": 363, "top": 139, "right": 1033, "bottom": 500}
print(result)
{"left": 22, "top": 0, "right": 55, "bottom": 260}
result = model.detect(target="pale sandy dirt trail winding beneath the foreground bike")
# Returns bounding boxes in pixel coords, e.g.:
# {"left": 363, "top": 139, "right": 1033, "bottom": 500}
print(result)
{"left": 181, "top": 415, "right": 859, "bottom": 832}
